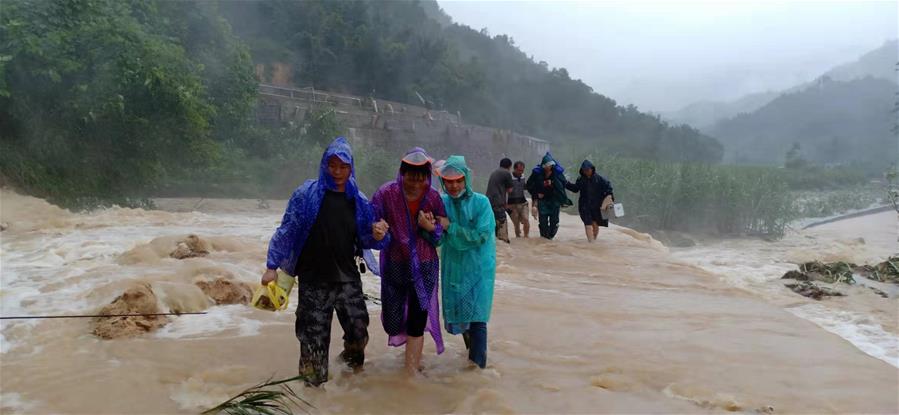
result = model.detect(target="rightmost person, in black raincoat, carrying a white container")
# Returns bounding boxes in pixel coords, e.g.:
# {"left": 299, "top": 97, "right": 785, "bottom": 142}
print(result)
{"left": 565, "top": 160, "right": 615, "bottom": 242}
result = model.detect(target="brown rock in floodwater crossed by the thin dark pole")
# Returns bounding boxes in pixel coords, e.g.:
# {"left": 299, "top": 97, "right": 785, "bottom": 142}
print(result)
{"left": 92, "top": 283, "right": 168, "bottom": 339}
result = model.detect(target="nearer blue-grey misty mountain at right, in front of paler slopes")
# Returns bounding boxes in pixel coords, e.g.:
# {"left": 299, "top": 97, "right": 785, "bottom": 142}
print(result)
{"left": 709, "top": 76, "right": 899, "bottom": 171}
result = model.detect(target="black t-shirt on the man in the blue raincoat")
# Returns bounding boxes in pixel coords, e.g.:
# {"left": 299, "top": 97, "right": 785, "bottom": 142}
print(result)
{"left": 296, "top": 191, "right": 359, "bottom": 282}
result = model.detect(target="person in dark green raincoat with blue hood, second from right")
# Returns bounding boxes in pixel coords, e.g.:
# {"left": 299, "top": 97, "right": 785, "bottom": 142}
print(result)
{"left": 527, "top": 152, "right": 572, "bottom": 239}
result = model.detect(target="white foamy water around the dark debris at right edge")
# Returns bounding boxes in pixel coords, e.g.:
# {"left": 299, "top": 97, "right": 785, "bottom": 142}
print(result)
{"left": 672, "top": 212, "right": 899, "bottom": 367}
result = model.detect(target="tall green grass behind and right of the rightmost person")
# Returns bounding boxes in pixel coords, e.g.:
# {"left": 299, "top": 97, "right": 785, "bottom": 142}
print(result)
{"left": 567, "top": 154, "right": 798, "bottom": 236}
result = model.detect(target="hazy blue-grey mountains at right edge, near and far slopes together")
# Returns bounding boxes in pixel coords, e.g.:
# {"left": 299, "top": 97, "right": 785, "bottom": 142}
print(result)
{"left": 675, "top": 39, "right": 899, "bottom": 176}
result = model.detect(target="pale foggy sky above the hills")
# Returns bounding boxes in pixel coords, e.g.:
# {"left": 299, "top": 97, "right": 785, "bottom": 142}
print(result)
{"left": 439, "top": 0, "right": 899, "bottom": 112}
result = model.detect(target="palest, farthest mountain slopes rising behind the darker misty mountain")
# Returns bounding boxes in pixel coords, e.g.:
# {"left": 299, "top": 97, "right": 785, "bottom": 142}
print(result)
{"left": 662, "top": 39, "right": 899, "bottom": 132}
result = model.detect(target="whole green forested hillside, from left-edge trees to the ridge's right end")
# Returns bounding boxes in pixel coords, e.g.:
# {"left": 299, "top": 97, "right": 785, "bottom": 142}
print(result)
{"left": 0, "top": 0, "right": 722, "bottom": 207}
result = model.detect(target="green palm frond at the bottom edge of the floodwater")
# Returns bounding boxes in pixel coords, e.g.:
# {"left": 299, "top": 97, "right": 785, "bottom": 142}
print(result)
{"left": 203, "top": 376, "right": 315, "bottom": 415}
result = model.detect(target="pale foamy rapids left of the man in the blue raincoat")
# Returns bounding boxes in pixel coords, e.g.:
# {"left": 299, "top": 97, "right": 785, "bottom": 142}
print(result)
{"left": 0, "top": 203, "right": 278, "bottom": 354}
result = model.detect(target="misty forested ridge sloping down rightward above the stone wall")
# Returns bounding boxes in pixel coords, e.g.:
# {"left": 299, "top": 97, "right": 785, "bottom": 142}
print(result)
{"left": 220, "top": 0, "right": 723, "bottom": 162}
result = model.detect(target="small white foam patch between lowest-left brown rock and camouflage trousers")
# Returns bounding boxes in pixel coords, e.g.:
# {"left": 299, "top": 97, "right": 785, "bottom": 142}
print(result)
{"left": 154, "top": 304, "right": 262, "bottom": 339}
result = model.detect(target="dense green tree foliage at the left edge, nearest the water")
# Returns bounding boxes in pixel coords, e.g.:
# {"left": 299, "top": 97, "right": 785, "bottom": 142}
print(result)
{"left": 0, "top": 0, "right": 255, "bottom": 205}
